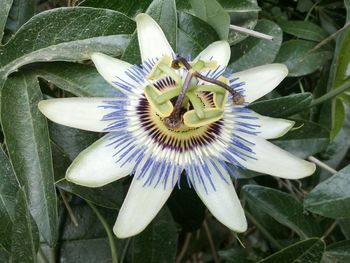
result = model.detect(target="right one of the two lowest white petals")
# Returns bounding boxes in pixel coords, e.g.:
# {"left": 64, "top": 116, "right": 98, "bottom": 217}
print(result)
{"left": 191, "top": 161, "right": 247, "bottom": 233}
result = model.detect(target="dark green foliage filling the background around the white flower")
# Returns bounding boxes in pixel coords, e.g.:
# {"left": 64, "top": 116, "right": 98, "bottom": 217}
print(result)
{"left": 0, "top": 0, "right": 350, "bottom": 263}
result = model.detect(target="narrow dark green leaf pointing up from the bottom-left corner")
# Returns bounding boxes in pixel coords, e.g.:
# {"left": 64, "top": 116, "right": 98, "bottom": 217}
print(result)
{"left": 11, "top": 187, "right": 39, "bottom": 263}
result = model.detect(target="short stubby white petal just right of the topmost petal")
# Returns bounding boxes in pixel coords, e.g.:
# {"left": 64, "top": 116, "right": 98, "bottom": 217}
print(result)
{"left": 194, "top": 41, "right": 231, "bottom": 67}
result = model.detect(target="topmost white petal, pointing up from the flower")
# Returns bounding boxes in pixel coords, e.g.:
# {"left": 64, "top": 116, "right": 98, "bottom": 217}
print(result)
{"left": 135, "top": 14, "right": 174, "bottom": 61}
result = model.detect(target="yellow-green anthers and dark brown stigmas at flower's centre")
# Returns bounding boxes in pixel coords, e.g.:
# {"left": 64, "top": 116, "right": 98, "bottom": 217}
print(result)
{"left": 145, "top": 56, "right": 244, "bottom": 130}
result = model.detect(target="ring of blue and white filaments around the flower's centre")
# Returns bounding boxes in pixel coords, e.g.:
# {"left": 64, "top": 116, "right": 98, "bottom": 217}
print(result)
{"left": 99, "top": 55, "right": 260, "bottom": 193}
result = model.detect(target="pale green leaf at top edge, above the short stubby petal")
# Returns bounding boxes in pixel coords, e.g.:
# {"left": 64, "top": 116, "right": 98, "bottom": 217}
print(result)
{"left": 190, "top": 0, "right": 230, "bottom": 40}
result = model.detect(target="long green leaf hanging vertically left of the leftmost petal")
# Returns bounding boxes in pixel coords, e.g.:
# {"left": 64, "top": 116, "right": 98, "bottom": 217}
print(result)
{"left": 1, "top": 73, "right": 58, "bottom": 245}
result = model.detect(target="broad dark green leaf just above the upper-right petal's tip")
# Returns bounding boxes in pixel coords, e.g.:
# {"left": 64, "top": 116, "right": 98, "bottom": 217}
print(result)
{"left": 276, "top": 40, "right": 332, "bottom": 77}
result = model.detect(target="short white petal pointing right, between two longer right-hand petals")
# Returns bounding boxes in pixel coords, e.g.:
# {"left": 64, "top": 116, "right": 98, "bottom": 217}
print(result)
{"left": 238, "top": 112, "right": 295, "bottom": 139}
